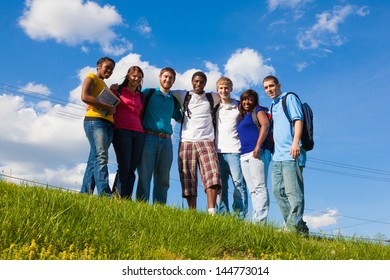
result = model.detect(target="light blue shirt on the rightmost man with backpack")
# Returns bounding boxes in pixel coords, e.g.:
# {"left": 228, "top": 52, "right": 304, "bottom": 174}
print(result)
{"left": 272, "top": 92, "right": 306, "bottom": 166}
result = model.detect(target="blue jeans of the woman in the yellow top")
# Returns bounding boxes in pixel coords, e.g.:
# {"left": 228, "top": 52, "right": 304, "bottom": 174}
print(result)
{"left": 80, "top": 119, "right": 114, "bottom": 196}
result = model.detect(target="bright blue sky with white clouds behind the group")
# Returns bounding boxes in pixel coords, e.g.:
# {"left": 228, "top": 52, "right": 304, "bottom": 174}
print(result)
{"left": 0, "top": 0, "right": 390, "bottom": 241}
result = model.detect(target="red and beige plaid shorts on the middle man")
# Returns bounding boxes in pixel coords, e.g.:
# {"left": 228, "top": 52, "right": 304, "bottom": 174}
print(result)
{"left": 179, "top": 141, "right": 221, "bottom": 197}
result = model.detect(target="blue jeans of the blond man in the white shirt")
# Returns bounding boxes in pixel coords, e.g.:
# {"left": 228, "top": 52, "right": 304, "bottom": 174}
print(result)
{"left": 216, "top": 153, "right": 248, "bottom": 219}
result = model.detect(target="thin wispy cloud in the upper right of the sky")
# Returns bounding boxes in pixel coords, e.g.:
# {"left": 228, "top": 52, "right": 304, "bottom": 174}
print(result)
{"left": 297, "top": 5, "right": 369, "bottom": 49}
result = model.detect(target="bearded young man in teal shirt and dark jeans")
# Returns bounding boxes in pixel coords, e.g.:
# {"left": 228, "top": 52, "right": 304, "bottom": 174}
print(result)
{"left": 137, "top": 67, "right": 182, "bottom": 204}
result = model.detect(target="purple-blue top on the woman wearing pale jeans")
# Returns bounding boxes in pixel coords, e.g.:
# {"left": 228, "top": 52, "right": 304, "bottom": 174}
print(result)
{"left": 237, "top": 107, "right": 264, "bottom": 155}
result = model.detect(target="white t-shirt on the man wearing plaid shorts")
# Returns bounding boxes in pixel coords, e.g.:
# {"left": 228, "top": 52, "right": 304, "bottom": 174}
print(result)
{"left": 174, "top": 91, "right": 220, "bottom": 142}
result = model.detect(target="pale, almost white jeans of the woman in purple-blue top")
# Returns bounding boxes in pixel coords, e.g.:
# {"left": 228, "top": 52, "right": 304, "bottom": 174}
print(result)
{"left": 241, "top": 149, "right": 271, "bottom": 223}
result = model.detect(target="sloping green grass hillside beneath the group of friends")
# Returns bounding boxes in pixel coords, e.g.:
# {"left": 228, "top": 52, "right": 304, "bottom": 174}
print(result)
{"left": 0, "top": 181, "right": 390, "bottom": 260}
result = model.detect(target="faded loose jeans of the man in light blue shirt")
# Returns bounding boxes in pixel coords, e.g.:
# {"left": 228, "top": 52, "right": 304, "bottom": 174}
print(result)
{"left": 272, "top": 160, "right": 309, "bottom": 233}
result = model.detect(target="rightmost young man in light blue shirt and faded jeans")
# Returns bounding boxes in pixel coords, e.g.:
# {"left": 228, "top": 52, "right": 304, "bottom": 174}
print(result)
{"left": 263, "top": 76, "right": 309, "bottom": 235}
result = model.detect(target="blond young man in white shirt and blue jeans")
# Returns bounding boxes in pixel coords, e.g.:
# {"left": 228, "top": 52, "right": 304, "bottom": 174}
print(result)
{"left": 215, "top": 77, "right": 248, "bottom": 219}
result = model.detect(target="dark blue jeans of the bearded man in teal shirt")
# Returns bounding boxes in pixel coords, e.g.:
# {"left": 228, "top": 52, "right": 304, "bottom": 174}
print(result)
{"left": 136, "top": 134, "right": 173, "bottom": 204}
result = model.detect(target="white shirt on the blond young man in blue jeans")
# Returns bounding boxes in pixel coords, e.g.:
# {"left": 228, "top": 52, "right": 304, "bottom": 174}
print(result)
{"left": 215, "top": 99, "right": 241, "bottom": 153}
